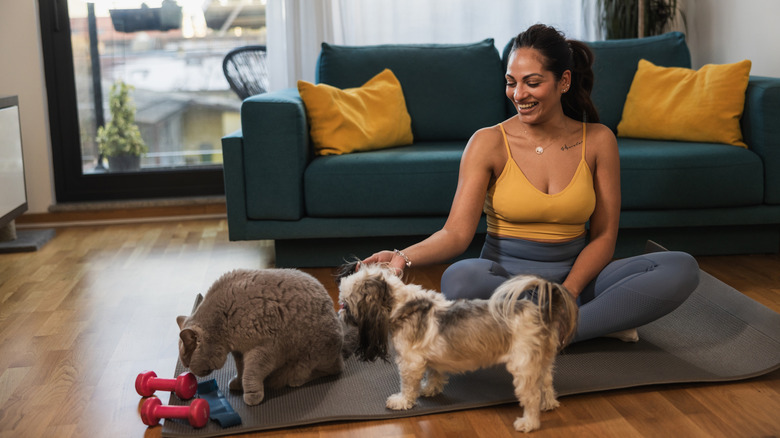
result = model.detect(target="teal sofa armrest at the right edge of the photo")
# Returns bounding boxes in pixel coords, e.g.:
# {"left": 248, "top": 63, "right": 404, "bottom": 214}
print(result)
{"left": 742, "top": 76, "right": 780, "bottom": 204}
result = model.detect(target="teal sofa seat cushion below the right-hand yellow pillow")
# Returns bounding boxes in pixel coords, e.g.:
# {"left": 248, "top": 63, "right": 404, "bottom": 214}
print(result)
{"left": 618, "top": 138, "right": 764, "bottom": 210}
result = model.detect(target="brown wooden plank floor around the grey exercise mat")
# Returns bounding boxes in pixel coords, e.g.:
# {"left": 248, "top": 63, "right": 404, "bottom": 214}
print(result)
{"left": 0, "top": 220, "right": 780, "bottom": 438}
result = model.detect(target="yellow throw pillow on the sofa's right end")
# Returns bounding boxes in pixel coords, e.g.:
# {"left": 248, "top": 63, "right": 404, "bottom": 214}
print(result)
{"left": 618, "top": 59, "right": 751, "bottom": 147}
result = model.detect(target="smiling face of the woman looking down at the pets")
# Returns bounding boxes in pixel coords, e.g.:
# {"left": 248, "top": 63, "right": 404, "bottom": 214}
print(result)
{"left": 506, "top": 47, "right": 571, "bottom": 124}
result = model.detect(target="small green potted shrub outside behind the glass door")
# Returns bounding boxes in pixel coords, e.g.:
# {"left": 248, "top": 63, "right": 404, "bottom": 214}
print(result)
{"left": 97, "top": 81, "right": 148, "bottom": 172}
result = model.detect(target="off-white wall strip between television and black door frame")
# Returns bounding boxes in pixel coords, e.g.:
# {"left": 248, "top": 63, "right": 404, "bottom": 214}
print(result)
{"left": 0, "top": 0, "right": 54, "bottom": 213}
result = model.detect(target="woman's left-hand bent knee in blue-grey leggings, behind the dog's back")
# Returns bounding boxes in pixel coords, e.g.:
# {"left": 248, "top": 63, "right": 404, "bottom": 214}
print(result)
{"left": 441, "top": 259, "right": 510, "bottom": 300}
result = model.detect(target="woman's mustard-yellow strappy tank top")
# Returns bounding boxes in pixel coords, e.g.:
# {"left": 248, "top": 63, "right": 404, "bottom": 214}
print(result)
{"left": 484, "top": 123, "right": 596, "bottom": 241}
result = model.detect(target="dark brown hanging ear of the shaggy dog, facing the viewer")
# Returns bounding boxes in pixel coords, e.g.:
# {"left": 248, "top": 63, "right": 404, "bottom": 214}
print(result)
{"left": 355, "top": 278, "right": 393, "bottom": 361}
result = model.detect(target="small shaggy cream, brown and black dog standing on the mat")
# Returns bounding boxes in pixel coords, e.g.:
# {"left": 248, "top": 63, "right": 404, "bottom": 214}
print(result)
{"left": 339, "top": 263, "right": 577, "bottom": 432}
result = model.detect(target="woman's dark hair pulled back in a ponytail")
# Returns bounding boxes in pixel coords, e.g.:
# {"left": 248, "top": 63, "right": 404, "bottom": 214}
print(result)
{"left": 512, "top": 24, "right": 599, "bottom": 122}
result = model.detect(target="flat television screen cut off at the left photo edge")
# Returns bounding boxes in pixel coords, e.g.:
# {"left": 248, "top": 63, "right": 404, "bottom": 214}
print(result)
{"left": 0, "top": 96, "right": 27, "bottom": 230}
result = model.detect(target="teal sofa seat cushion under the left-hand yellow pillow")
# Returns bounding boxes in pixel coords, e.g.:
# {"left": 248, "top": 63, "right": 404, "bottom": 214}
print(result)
{"left": 304, "top": 141, "right": 466, "bottom": 217}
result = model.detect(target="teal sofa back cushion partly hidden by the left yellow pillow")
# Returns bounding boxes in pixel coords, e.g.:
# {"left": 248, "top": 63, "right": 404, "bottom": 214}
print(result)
{"left": 316, "top": 39, "right": 506, "bottom": 141}
